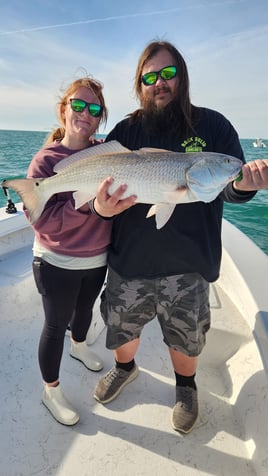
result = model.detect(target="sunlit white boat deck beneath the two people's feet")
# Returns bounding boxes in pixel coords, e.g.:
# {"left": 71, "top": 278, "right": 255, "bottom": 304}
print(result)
{"left": 0, "top": 246, "right": 268, "bottom": 476}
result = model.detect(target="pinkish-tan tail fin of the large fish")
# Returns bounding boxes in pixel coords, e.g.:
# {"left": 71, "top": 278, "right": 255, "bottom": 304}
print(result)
{"left": 2, "top": 179, "right": 46, "bottom": 225}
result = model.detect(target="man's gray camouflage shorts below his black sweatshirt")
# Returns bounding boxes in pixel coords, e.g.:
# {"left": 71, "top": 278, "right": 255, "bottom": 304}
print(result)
{"left": 101, "top": 268, "right": 210, "bottom": 357}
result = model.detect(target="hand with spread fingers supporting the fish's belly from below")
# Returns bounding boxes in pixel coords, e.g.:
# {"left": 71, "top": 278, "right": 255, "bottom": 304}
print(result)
{"left": 94, "top": 177, "right": 137, "bottom": 217}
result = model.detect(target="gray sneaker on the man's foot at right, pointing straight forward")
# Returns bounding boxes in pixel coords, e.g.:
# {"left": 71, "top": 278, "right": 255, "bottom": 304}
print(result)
{"left": 172, "top": 386, "right": 198, "bottom": 433}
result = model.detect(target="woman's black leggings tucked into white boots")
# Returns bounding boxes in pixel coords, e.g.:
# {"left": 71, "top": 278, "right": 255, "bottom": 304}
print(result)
{"left": 33, "top": 258, "right": 106, "bottom": 383}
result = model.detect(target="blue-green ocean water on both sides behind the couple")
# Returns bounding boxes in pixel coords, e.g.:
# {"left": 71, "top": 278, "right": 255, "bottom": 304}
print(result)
{"left": 0, "top": 130, "right": 268, "bottom": 255}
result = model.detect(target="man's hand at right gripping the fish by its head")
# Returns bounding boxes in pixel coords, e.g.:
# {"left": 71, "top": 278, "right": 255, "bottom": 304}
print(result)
{"left": 233, "top": 159, "right": 268, "bottom": 192}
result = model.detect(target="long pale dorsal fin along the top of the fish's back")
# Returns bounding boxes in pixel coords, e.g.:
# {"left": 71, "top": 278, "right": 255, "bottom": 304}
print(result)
{"left": 53, "top": 140, "right": 130, "bottom": 173}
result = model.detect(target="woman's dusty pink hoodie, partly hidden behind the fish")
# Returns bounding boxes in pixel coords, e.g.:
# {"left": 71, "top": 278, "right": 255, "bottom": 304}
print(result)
{"left": 25, "top": 142, "right": 112, "bottom": 258}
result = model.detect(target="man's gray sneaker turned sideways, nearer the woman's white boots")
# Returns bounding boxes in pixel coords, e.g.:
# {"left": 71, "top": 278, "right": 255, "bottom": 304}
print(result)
{"left": 94, "top": 364, "right": 139, "bottom": 403}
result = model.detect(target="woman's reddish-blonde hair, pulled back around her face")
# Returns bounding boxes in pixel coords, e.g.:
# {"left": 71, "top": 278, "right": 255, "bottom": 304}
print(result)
{"left": 45, "top": 76, "right": 108, "bottom": 145}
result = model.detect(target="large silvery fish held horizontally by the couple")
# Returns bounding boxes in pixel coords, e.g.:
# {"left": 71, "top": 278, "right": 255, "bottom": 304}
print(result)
{"left": 2, "top": 141, "right": 243, "bottom": 229}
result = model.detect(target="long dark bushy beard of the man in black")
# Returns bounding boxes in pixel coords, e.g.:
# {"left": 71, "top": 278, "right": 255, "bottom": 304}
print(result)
{"left": 142, "top": 92, "right": 182, "bottom": 135}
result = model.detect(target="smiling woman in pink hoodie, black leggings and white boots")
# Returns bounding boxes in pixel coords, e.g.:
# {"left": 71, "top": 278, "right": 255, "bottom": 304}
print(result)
{"left": 25, "top": 77, "right": 111, "bottom": 425}
